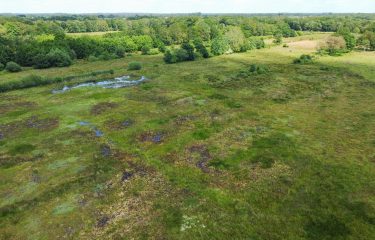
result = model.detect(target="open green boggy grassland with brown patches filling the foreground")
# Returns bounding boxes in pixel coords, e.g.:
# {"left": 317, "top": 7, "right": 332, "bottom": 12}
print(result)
{"left": 0, "top": 34, "right": 375, "bottom": 240}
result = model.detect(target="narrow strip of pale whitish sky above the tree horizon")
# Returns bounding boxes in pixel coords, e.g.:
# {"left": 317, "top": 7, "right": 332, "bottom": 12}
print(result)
{"left": 0, "top": 0, "right": 375, "bottom": 13}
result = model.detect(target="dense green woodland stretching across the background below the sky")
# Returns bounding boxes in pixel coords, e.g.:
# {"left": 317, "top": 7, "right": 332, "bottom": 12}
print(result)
{"left": 0, "top": 15, "right": 375, "bottom": 71}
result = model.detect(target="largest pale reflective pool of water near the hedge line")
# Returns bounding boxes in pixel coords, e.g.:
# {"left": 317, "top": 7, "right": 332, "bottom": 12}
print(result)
{"left": 52, "top": 76, "right": 147, "bottom": 94}
